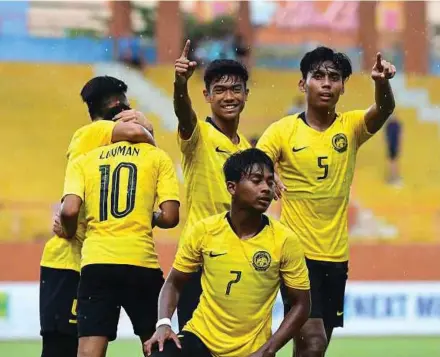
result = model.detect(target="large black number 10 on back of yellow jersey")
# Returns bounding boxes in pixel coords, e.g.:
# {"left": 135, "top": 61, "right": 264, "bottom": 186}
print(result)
{"left": 99, "top": 162, "right": 137, "bottom": 222}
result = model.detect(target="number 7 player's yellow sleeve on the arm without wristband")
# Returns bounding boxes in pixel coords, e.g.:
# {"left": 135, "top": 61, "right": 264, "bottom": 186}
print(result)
{"left": 280, "top": 234, "right": 310, "bottom": 290}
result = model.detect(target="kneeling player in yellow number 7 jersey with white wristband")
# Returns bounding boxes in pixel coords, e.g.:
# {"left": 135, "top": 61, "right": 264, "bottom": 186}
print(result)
{"left": 144, "top": 149, "right": 310, "bottom": 357}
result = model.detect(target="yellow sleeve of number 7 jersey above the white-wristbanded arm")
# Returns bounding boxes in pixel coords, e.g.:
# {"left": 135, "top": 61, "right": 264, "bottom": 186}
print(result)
{"left": 173, "top": 223, "right": 205, "bottom": 273}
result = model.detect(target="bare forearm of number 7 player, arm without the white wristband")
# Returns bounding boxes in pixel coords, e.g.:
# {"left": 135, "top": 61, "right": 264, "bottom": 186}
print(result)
{"left": 262, "top": 292, "right": 310, "bottom": 356}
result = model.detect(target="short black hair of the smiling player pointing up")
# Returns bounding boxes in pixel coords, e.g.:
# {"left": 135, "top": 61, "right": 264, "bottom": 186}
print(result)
{"left": 203, "top": 59, "right": 249, "bottom": 90}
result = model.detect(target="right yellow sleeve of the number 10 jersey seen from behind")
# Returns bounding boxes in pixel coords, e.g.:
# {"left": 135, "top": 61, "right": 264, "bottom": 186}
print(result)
{"left": 157, "top": 151, "right": 180, "bottom": 205}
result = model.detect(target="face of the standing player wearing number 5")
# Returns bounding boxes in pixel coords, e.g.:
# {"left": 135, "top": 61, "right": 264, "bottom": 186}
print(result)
{"left": 300, "top": 62, "right": 344, "bottom": 109}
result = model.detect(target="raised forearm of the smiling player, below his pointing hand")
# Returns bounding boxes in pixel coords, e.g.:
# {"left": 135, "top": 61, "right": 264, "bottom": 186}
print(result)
{"left": 174, "top": 81, "right": 197, "bottom": 135}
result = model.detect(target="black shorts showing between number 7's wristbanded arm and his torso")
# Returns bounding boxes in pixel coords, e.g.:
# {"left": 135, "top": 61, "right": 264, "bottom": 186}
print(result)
{"left": 177, "top": 269, "right": 202, "bottom": 331}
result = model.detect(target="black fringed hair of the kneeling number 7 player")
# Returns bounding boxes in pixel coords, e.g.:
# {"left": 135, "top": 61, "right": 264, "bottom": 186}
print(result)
{"left": 223, "top": 148, "right": 275, "bottom": 182}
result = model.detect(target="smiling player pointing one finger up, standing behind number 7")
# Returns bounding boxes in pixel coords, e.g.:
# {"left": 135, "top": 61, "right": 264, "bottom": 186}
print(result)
{"left": 174, "top": 40, "right": 251, "bottom": 327}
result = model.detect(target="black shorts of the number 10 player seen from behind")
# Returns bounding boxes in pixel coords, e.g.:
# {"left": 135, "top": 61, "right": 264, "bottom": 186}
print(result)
{"left": 78, "top": 264, "right": 164, "bottom": 341}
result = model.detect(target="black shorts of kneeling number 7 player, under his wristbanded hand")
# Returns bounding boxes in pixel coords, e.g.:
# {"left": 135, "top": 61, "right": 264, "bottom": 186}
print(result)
{"left": 150, "top": 331, "right": 212, "bottom": 357}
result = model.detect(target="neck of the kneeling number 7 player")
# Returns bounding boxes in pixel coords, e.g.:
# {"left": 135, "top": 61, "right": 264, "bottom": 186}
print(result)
{"left": 229, "top": 206, "right": 263, "bottom": 239}
